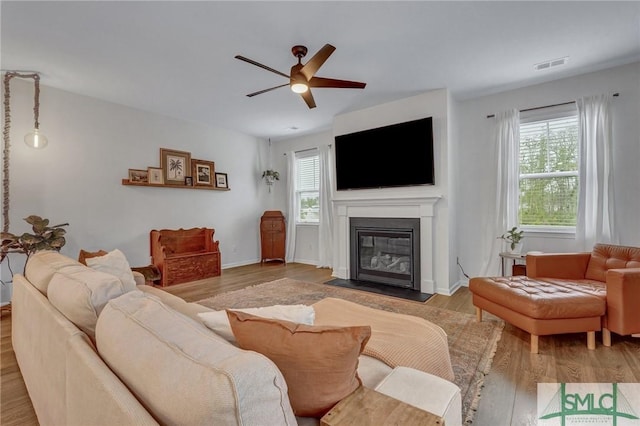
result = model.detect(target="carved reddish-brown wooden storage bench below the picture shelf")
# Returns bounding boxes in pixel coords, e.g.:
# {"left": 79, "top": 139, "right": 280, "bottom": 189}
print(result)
{"left": 149, "top": 228, "right": 221, "bottom": 287}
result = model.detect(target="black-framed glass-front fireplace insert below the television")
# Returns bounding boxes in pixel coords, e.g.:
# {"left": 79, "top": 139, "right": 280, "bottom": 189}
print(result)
{"left": 349, "top": 217, "right": 420, "bottom": 291}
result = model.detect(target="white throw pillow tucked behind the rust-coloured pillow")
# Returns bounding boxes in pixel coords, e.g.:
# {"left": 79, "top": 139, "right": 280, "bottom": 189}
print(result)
{"left": 198, "top": 305, "right": 316, "bottom": 343}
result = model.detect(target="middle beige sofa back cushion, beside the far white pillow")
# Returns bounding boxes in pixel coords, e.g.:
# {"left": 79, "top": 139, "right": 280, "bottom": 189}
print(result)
{"left": 48, "top": 265, "right": 138, "bottom": 341}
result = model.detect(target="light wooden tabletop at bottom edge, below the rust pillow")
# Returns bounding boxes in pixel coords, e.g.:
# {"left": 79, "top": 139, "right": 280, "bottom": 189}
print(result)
{"left": 320, "top": 386, "right": 444, "bottom": 426}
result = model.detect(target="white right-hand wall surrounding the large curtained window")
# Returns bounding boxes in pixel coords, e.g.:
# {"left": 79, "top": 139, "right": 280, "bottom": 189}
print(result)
{"left": 453, "top": 63, "right": 640, "bottom": 276}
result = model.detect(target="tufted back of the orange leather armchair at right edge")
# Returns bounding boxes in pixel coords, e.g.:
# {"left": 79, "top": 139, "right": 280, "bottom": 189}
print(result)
{"left": 585, "top": 244, "right": 640, "bottom": 282}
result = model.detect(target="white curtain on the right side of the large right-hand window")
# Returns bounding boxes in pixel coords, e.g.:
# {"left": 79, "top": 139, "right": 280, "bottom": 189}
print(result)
{"left": 576, "top": 95, "right": 618, "bottom": 251}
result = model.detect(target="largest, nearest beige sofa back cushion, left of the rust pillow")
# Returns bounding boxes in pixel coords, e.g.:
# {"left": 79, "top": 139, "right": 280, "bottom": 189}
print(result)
{"left": 96, "top": 292, "right": 296, "bottom": 425}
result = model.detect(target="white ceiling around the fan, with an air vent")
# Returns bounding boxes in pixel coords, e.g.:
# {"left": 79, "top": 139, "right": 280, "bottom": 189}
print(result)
{"left": 0, "top": 1, "right": 640, "bottom": 140}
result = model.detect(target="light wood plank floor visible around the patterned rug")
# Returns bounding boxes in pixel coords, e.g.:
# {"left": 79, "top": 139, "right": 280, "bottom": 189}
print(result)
{"left": 0, "top": 263, "right": 640, "bottom": 426}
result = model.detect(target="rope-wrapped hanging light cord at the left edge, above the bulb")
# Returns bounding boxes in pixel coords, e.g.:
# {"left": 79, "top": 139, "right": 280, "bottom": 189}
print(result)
{"left": 2, "top": 71, "right": 40, "bottom": 232}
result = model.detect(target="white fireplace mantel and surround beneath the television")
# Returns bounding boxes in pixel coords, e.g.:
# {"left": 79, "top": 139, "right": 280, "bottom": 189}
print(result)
{"left": 333, "top": 195, "right": 442, "bottom": 293}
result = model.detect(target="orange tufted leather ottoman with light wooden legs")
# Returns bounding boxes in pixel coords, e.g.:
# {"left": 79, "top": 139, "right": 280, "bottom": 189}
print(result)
{"left": 469, "top": 276, "right": 606, "bottom": 353}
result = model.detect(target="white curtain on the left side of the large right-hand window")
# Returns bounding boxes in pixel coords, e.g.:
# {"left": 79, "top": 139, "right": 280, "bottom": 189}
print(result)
{"left": 480, "top": 109, "right": 520, "bottom": 276}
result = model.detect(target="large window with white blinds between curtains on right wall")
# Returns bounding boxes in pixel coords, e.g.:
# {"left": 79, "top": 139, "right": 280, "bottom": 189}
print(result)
{"left": 518, "top": 108, "right": 578, "bottom": 231}
